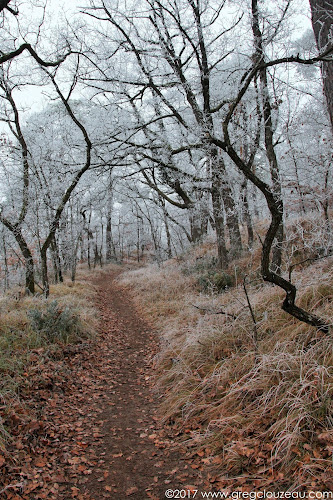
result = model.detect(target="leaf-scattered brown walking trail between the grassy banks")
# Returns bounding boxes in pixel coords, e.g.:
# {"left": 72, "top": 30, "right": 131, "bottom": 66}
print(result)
{"left": 51, "top": 273, "right": 201, "bottom": 500}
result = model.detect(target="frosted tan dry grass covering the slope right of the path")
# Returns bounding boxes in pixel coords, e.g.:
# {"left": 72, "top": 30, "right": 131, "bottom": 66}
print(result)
{"left": 122, "top": 242, "right": 333, "bottom": 488}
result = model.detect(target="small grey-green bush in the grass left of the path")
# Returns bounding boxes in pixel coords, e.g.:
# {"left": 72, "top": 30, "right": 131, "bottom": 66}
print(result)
{"left": 27, "top": 300, "right": 80, "bottom": 343}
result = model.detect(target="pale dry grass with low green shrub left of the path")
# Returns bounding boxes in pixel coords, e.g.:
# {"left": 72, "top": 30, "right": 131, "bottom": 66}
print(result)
{"left": 0, "top": 281, "right": 96, "bottom": 452}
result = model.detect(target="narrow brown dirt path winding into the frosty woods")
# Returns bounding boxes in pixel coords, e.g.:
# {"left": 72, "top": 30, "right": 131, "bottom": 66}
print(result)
{"left": 70, "top": 275, "right": 200, "bottom": 500}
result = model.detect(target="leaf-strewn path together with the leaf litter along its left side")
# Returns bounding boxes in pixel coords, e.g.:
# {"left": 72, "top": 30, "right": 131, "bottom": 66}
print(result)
{"left": 1, "top": 272, "right": 210, "bottom": 500}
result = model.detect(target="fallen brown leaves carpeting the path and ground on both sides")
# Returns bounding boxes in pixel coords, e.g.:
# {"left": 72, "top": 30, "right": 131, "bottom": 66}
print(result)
{"left": 0, "top": 275, "right": 333, "bottom": 500}
